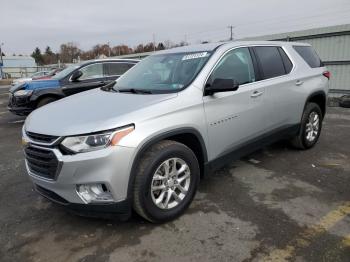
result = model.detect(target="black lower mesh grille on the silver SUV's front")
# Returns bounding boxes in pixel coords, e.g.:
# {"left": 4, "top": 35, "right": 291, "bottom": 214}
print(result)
{"left": 24, "top": 146, "right": 59, "bottom": 179}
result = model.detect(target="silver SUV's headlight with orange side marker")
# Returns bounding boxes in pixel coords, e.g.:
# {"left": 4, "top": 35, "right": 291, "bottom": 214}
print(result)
{"left": 61, "top": 125, "right": 134, "bottom": 153}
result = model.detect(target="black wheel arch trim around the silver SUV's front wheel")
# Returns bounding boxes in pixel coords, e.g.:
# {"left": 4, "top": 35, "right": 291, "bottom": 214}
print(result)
{"left": 127, "top": 127, "right": 208, "bottom": 200}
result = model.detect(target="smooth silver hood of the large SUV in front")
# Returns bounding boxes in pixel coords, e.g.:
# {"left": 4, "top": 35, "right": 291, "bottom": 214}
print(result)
{"left": 25, "top": 89, "right": 177, "bottom": 136}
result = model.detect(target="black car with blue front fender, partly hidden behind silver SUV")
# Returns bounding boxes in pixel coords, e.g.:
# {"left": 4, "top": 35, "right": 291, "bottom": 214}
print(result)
{"left": 8, "top": 59, "right": 138, "bottom": 115}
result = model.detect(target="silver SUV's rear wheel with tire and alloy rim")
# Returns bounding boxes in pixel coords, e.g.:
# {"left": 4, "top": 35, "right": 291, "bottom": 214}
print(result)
{"left": 291, "top": 103, "right": 323, "bottom": 150}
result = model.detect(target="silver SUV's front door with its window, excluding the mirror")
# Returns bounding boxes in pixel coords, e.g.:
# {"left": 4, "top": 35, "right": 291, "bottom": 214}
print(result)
{"left": 203, "top": 47, "right": 267, "bottom": 159}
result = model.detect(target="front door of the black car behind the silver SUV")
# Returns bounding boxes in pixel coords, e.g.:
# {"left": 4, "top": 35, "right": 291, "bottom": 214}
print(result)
{"left": 62, "top": 62, "right": 106, "bottom": 95}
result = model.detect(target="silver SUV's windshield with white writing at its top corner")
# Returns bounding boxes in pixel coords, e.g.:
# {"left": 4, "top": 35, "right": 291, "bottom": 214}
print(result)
{"left": 113, "top": 52, "right": 210, "bottom": 93}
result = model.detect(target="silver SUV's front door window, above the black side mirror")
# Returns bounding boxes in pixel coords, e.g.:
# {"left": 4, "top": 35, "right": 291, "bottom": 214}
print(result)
{"left": 209, "top": 47, "right": 255, "bottom": 85}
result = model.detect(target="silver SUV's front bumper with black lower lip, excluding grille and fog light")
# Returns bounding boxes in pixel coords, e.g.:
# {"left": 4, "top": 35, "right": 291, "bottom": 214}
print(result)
{"left": 25, "top": 135, "right": 135, "bottom": 217}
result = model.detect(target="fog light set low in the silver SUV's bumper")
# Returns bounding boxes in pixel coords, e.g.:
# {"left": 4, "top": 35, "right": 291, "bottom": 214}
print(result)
{"left": 77, "top": 184, "right": 114, "bottom": 204}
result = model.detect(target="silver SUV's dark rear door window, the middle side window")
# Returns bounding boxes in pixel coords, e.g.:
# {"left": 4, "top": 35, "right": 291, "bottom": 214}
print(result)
{"left": 254, "top": 46, "right": 286, "bottom": 79}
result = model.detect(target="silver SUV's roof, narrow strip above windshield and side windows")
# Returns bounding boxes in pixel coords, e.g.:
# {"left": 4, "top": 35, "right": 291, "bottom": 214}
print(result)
{"left": 156, "top": 41, "right": 309, "bottom": 54}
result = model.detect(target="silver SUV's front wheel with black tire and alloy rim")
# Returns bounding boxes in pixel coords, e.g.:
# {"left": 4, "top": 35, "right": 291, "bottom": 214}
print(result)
{"left": 133, "top": 140, "right": 200, "bottom": 223}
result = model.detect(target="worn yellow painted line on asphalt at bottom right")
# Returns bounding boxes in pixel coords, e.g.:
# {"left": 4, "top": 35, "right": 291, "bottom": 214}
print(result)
{"left": 263, "top": 202, "right": 350, "bottom": 262}
